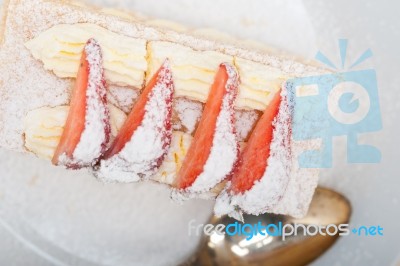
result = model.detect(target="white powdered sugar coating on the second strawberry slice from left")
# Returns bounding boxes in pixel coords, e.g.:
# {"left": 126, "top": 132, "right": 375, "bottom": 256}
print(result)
{"left": 96, "top": 60, "right": 174, "bottom": 182}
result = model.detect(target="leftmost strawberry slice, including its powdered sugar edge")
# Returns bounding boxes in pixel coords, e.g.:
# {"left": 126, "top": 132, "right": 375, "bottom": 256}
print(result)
{"left": 52, "top": 39, "right": 111, "bottom": 169}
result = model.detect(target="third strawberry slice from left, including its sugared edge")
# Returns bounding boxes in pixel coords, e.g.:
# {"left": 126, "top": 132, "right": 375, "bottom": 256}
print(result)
{"left": 174, "top": 63, "right": 239, "bottom": 192}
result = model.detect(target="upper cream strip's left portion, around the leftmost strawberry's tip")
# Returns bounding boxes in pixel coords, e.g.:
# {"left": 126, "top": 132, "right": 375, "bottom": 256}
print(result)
{"left": 25, "top": 23, "right": 147, "bottom": 88}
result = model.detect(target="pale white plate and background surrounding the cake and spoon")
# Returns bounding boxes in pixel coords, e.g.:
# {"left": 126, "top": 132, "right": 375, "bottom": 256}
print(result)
{"left": 0, "top": 0, "right": 400, "bottom": 265}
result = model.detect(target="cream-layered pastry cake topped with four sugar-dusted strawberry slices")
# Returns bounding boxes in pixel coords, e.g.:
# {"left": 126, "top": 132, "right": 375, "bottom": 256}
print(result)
{"left": 0, "top": 0, "right": 324, "bottom": 219}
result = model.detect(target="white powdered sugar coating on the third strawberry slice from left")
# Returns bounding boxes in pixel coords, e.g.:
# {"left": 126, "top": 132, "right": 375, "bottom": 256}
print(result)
{"left": 182, "top": 63, "right": 239, "bottom": 193}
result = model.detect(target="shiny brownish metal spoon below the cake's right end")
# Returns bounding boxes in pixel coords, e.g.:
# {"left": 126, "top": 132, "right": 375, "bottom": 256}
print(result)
{"left": 190, "top": 188, "right": 351, "bottom": 265}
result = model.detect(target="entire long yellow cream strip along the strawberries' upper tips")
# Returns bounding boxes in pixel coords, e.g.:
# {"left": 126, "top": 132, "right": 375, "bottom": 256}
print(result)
{"left": 26, "top": 23, "right": 285, "bottom": 111}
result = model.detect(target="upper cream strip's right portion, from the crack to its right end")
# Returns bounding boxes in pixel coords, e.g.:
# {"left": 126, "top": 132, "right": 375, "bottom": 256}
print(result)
{"left": 148, "top": 41, "right": 287, "bottom": 111}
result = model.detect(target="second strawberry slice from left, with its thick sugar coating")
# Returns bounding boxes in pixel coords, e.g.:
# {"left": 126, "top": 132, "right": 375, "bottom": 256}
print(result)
{"left": 97, "top": 59, "right": 174, "bottom": 182}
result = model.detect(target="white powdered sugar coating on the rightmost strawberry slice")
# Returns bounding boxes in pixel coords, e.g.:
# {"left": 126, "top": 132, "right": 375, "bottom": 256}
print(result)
{"left": 215, "top": 89, "right": 293, "bottom": 217}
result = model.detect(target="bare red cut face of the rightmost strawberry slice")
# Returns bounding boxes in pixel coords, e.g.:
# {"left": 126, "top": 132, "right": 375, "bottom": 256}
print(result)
{"left": 231, "top": 91, "right": 281, "bottom": 194}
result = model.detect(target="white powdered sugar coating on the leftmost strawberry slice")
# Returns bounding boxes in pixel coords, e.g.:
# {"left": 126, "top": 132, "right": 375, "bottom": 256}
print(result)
{"left": 59, "top": 39, "right": 111, "bottom": 166}
